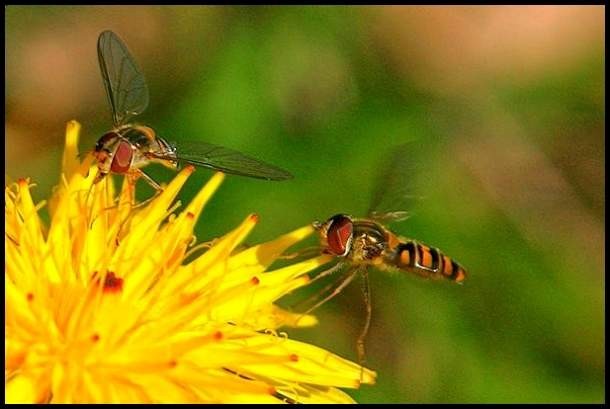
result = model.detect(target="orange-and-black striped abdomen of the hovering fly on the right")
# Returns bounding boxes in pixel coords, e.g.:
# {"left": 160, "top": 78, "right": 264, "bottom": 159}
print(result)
{"left": 387, "top": 240, "right": 466, "bottom": 283}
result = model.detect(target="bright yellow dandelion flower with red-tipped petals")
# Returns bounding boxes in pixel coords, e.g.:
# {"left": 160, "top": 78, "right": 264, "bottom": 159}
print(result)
{"left": 5, "top": 121, "right": 376, "bottom": 403}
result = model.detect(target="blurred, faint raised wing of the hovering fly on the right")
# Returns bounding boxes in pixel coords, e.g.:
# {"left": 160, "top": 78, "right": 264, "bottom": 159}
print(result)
{"left": 368, "top": 142, "right": 422, "bottom": 223}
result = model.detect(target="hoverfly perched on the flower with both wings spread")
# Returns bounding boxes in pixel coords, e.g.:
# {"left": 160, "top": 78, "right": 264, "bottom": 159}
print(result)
{"left": 93, "top": 31, "right": 292, "bottom": 191}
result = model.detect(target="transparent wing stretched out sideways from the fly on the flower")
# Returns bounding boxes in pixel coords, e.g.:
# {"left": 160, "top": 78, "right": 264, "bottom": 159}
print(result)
{"left": 146, "top": 142, "right": 292, "bottom": 180}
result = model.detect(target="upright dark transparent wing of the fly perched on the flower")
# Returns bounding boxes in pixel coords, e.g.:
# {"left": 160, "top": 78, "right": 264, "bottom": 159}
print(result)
{"left": 97, "top": 30, "right": 148, "bottom": 127}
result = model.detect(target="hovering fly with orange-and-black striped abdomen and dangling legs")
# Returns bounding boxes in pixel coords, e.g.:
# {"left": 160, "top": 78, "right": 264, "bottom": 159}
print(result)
{"left": 305, "top": 143, "right": 466, "bottom": 372}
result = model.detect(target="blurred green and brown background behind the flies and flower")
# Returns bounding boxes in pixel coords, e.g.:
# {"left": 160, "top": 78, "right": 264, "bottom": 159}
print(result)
{"left": 5, "top": 6, "right": 605, "bottom": 402}
